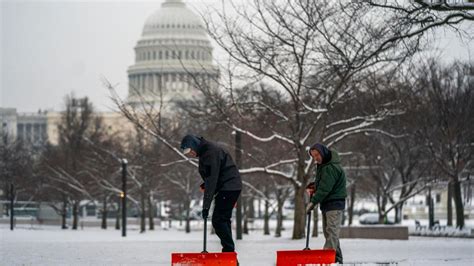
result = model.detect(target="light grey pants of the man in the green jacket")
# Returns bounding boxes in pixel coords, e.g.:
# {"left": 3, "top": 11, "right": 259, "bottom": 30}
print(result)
{"left": 323, "top": 210, "right": 343, "bottom": 264}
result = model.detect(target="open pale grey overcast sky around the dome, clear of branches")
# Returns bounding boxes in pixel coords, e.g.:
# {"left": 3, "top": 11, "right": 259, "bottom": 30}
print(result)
{"left": 0, "top": 0, "right": 474, "bottom": 112}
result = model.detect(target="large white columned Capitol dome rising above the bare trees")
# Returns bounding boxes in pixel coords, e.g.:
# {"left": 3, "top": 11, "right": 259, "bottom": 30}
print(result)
{"left": 127, "top": 0, "right": 219, "bottom": 106}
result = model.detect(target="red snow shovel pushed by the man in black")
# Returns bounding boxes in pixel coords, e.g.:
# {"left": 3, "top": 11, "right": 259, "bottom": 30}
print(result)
{"left": 171, "top": 218, "right": 237, "bottom": 266}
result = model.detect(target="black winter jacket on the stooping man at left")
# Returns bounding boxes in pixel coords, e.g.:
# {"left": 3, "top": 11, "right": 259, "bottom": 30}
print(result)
{"left": 197, "top": 138, "right": 242, "bottom": 209}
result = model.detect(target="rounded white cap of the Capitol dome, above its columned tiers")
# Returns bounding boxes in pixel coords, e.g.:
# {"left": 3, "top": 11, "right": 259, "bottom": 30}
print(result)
{"left": 142, "top": 0, "right": 207, "bottom": 39}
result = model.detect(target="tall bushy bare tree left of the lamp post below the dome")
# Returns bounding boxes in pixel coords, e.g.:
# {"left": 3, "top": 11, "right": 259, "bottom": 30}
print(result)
{"left": 41, "top": 95, "right": 102, "bottom": 229}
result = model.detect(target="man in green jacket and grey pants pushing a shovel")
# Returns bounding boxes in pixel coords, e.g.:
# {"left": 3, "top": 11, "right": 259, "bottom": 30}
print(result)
{"left": 306, "top": 143, "right": 347, "bottom": 264}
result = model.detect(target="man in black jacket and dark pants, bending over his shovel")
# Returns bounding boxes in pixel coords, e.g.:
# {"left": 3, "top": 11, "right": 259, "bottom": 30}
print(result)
{"left": 181, "top": 135, "right": 242, "bottom": 252}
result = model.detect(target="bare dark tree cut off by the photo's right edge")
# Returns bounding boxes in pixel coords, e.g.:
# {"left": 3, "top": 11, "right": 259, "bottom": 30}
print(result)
{"left": 416, "top": 61, "right": 474, "bottom": 228}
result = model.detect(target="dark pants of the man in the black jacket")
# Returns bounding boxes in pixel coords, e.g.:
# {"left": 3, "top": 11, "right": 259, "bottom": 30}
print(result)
{"left": 212, "top": 190, "right": 240, "bottom": 252}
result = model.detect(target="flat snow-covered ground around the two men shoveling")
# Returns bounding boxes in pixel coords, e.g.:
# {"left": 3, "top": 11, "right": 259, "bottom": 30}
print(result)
{"left": 0, "top": 224, "right": 474, "bottom": 266}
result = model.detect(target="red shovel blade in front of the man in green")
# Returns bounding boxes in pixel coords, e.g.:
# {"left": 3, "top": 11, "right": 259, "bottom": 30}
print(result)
{"left": 277, "top": 249, "right": 336, "bottom": 266}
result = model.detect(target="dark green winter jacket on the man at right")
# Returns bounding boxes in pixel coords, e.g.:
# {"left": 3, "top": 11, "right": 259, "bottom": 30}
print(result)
{"left": 311, "top": 150, "right": 347, "bottom": 204}
